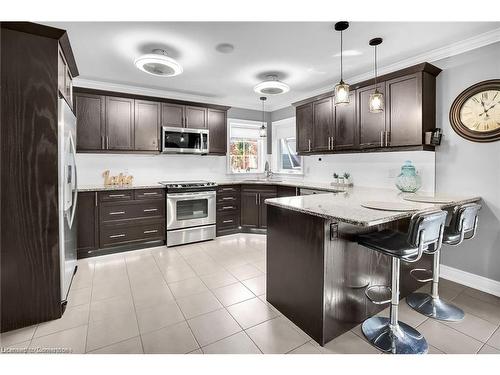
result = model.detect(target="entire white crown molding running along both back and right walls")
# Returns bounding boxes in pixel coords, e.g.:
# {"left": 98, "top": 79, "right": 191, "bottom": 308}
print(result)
{"left": 74, "top": 28, "right": 500, "bottom": 112}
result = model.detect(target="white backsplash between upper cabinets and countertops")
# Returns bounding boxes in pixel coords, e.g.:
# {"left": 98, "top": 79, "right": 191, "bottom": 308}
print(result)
{"left": 77, "top": 151, "right": 435, "bottom": 192}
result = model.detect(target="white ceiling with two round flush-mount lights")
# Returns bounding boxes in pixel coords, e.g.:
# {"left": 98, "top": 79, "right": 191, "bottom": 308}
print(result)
{"left": 45, "top": 22, "right": 500, "bottom": 110}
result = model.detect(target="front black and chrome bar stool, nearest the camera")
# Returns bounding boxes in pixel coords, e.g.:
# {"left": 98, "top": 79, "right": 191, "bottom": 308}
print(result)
{"left": 358, "top": 210, "right": 446, "bottom": 354}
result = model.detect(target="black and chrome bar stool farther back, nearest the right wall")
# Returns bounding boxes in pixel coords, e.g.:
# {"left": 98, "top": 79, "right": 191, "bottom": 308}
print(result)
{"left": 406, "top": 203, "right": 481, "bottom": 322}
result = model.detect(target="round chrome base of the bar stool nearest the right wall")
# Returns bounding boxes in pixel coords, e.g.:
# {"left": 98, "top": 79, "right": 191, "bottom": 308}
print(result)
{"left": 406, "top": 293, "right": 465, "bottom": 322}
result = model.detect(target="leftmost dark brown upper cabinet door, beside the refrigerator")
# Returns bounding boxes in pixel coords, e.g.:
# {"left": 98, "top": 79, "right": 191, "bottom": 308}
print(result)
{"left": 75, "top": 93, "right": 106, "bottom": 151}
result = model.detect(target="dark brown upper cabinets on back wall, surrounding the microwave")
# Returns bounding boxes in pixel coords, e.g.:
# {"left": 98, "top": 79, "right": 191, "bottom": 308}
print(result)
{"left": 74, "top": 88, "right": 229, "bottom": 155}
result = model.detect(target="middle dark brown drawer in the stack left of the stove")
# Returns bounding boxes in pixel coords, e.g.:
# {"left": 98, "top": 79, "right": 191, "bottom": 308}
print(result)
{"left": 100, "top": 199, "right": 165, "bottom": 222}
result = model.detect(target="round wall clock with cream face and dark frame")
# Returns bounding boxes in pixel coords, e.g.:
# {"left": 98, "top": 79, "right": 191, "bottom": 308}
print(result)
{"left": 450, "top": 79, "right": 500, "bottom": 142}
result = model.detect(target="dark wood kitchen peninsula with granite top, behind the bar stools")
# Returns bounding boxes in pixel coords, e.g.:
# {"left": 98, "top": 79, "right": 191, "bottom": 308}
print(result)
{"left": 265, "top": 187, "right": 480, "bottom": 345}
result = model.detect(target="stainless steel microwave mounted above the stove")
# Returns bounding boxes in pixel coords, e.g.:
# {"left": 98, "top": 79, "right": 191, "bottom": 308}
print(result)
{"left": 161, "top": 126, "right": 209, "bottom": 155}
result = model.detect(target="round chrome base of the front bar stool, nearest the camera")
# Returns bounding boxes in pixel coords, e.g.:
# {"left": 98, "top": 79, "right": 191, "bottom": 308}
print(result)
{"left": 361, "top": 316, "right": 429, "bottom": 354}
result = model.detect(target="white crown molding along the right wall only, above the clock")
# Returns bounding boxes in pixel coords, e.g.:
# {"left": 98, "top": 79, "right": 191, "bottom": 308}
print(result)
{"left": 272, "top": 28, "right": 500, "bottom": 111}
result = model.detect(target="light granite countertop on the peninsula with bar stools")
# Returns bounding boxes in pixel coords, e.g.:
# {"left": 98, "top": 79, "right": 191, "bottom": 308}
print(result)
{"left": 265, "top": 187, "right": 481, "bottom": 227}
